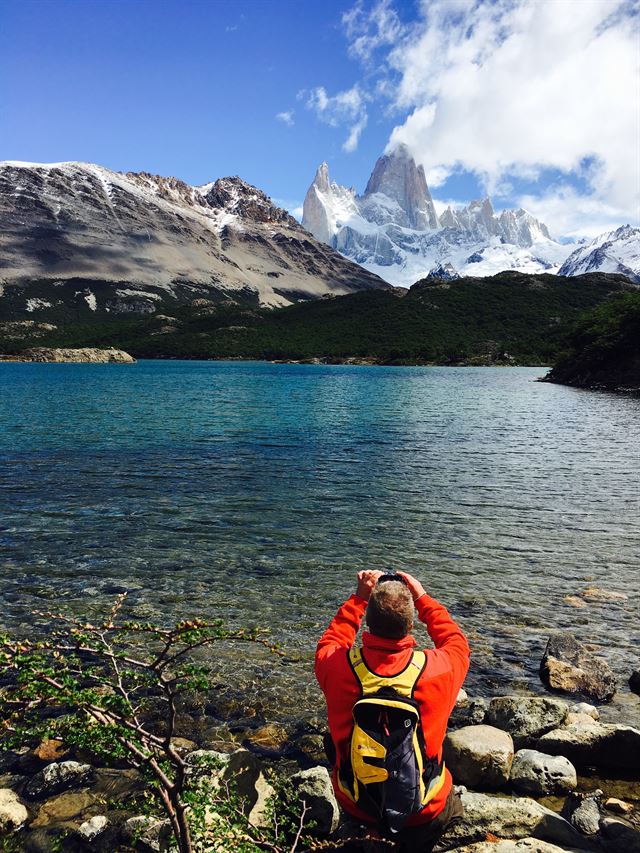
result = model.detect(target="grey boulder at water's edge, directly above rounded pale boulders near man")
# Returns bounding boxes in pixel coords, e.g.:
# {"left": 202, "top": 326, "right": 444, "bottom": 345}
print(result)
{"left": 487, "top": 696, "right": 568, "bottom": 747}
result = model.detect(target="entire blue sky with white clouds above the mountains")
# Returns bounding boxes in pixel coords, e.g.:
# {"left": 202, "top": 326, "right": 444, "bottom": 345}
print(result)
{"left": 0, "top": 0, "right": 638, "bottom": 236}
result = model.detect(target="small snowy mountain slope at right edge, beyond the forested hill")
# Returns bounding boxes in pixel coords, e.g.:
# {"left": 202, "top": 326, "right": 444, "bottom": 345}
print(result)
{"left": 558, "top": 225, "right": 640, "bottom": 284}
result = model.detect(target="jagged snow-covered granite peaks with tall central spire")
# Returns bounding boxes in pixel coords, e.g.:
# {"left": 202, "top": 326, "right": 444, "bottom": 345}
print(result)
{"left": 302, "top": 145, "right": 573, "bottom": 285}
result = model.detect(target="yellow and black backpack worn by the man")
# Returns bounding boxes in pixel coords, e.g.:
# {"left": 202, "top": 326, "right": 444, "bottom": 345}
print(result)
{"left": 338, "top": 647, "right": 445, "bottom": 833}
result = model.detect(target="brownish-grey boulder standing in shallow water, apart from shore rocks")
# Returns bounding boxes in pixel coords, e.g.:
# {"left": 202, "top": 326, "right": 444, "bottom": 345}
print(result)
{"left": 540, "top": 634, "right": 617, "bottom": 702}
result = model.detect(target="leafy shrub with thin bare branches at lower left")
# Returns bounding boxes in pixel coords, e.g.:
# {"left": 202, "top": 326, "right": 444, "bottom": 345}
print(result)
{"left": 0, "top": 594, "right": 281, "bottom": 853}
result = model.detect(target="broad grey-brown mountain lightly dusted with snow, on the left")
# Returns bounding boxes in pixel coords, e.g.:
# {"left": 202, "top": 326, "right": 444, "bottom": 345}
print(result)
{"left": 0, "top": 162, "right": 388, "bottom": 320}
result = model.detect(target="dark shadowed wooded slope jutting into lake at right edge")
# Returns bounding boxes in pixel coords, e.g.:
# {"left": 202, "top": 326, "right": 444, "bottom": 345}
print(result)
{"left": 547, "top": 291, "right": 640, "bottom": 392}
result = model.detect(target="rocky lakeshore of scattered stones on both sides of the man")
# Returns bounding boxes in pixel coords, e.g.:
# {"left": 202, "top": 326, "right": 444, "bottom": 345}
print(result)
{"left": 0, "top": 635, "right": 640, "bottom": 853}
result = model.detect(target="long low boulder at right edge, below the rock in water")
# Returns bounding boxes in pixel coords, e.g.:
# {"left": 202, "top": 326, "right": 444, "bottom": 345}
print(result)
{"left": 536, "top": 720, "right": 640, "bottom": 770}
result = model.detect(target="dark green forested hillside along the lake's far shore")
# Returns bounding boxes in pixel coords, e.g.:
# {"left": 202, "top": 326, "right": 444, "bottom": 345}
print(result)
{"left": 0, "top": 272, "right": 632, "bottom": 364}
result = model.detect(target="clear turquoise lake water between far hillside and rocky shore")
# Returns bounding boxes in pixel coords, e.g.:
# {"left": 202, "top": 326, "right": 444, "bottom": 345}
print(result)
{"left": 0, "top": 361, "right": 640, "bottom": 722}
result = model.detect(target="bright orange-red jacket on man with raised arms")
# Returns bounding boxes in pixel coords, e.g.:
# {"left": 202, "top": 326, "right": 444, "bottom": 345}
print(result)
{"left": 315, "top": 593, "right": 469, "bottom": 826}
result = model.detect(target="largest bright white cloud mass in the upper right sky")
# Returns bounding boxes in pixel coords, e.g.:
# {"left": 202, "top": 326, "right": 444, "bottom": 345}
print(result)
{"left": 343, "top": 0, "right": 640, "bottom": 234}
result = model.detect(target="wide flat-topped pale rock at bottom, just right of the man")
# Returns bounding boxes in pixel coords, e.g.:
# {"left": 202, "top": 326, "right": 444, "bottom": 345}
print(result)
{"left": 435, "top": 793, "right": 593, "bottom": 851}
